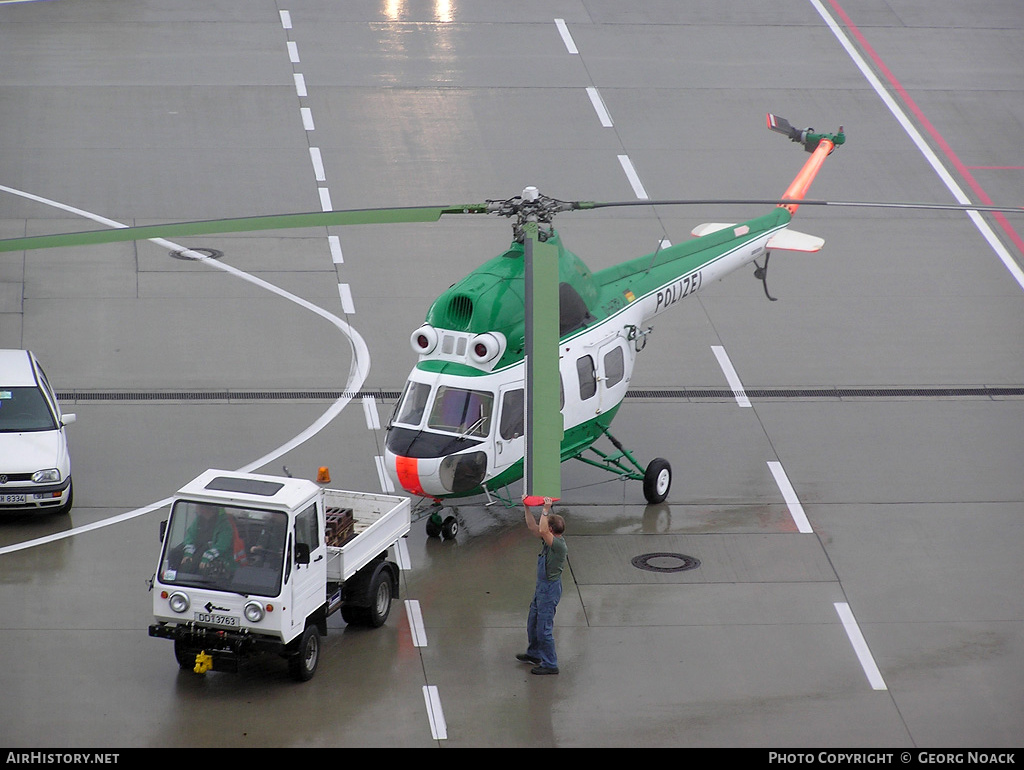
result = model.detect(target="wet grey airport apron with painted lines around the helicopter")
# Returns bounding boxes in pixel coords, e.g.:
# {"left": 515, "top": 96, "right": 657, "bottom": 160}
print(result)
{"left": 0, "top": 0, "right": 1024, "bottom": 758}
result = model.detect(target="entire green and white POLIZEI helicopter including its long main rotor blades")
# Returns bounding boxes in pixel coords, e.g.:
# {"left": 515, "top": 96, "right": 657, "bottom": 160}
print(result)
{"left": 6, "top": 113, "right": 1024, "bottom": 538}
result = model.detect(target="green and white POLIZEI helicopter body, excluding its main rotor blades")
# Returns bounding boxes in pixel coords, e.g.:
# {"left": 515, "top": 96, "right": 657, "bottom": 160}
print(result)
{"left": 384, "top": 114, "right": 845, "bottom": 538}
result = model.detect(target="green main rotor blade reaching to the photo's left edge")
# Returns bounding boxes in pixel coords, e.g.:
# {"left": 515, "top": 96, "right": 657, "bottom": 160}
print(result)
{"left": 0, "top": 204, "right": 487, "bottom": 252}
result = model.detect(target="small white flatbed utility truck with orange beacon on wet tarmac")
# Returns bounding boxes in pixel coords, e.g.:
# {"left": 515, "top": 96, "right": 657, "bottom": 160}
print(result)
{"left": 150, "top": 470, "right": 410, "bottom": 681}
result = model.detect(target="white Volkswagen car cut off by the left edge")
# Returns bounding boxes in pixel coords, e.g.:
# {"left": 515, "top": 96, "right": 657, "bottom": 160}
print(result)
{"left": 0, "top": 350, "right": 75, "bottom": 513}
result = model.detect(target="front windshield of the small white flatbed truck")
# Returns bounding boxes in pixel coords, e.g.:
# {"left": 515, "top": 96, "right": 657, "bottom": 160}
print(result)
{"left": 160, "top": 500, "right": 288, "bottom": 596}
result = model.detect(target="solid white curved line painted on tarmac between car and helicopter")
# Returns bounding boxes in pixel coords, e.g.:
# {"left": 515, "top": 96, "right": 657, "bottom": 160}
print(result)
{"left": 0, "top": 184, "right": 370, "bottom": 556}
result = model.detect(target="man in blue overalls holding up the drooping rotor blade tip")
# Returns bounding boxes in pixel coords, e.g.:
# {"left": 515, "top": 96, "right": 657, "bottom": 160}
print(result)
{"left": 516, "top": 496, "right": 568, "bottom": 674}
